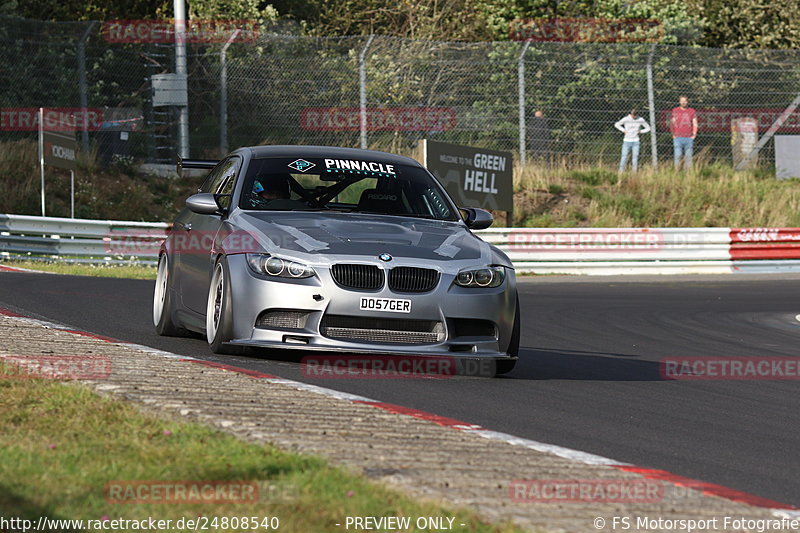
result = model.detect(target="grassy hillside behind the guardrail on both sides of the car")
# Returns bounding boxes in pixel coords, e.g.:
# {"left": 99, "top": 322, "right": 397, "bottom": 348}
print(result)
{"left": 6, "top": 141, "right": 800, "bottom": 227}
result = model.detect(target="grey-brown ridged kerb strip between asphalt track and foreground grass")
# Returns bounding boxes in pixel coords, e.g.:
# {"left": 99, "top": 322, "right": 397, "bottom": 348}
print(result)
{"left": 0, "top": 316, "right": 797, "bottom": 533}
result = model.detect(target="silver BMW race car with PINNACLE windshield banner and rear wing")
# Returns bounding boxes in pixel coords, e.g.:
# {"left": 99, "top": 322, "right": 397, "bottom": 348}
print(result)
{"left": 153, "top": 146, "right": 520, "bottom": 374}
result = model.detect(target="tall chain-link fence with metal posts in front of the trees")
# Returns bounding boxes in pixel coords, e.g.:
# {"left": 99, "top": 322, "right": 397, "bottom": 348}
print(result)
{"left": 0, "top": 18, "right": 800, "bottom": 163}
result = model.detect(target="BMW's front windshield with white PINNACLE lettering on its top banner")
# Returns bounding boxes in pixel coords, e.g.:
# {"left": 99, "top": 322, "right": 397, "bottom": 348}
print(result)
{"left": 239, "top": 158, "right": 458, "bottom": 220}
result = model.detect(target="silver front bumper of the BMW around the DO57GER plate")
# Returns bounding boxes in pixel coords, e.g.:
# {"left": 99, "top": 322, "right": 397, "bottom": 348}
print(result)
{"left": 227, "top": 254, "right": 516, "bottom": 359}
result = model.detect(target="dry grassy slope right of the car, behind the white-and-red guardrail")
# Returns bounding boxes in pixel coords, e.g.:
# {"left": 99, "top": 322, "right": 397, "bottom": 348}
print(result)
{"left": 514, "top": 163, "right": 800, "bottom": 228}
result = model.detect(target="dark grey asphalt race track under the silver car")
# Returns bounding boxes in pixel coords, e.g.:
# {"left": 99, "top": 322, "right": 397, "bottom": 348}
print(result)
{"left": 0, "top": 272, "right": 800, "bottom": 506}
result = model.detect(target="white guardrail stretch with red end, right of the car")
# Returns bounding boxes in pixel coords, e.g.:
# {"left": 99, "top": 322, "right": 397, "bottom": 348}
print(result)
{"left": 478, "top": 228, "right": 800, "bottom": 275}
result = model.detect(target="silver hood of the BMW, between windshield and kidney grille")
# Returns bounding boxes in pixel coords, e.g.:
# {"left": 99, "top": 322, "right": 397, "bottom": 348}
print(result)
{"left": 230, "top": 211, "right": 493, "bottom": 261}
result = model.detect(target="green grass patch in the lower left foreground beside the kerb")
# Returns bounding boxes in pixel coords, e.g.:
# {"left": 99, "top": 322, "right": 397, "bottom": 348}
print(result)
{"left": 0, "top": 378, "right": 518, "bottom": 532}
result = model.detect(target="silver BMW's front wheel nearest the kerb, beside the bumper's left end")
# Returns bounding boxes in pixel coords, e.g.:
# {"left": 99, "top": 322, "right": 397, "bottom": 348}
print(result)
{"left": 206, "top": 257, "right": 243, "bottom": 355}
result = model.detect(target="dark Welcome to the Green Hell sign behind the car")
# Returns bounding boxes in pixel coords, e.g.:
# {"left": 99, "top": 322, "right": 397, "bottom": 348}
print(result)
{"left": 421, "top": 139, "right": 514, "bottom": 215}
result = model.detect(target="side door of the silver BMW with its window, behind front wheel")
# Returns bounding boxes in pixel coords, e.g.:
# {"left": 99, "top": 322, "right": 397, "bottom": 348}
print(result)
{"left": 178, "top": 156, "right": 242, "bottom": 314}
